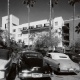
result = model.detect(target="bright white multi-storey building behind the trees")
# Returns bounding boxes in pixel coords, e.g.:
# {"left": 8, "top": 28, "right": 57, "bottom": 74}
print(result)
{"left": 2, "top": 15, "right": 64, "bottom": 47}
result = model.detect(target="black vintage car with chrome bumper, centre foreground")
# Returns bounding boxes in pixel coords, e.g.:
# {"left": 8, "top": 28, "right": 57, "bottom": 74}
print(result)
{"left": 18, "top": 51, "right": 52, "bottom": 80}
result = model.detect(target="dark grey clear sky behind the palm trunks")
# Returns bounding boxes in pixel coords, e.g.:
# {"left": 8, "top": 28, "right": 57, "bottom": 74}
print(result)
{"left": 0, "top": 0, "right": 80, "bottom": 26}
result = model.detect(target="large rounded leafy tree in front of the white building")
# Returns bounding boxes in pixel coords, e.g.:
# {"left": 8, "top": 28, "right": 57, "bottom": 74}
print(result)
{"left": 34, "top": 32, "right": 60, "bottom": 55}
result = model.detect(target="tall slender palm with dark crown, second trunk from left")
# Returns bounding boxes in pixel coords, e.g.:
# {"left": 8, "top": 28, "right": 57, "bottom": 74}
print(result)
{"left": 23, "top": 0, "right": 36, "bottom": 49}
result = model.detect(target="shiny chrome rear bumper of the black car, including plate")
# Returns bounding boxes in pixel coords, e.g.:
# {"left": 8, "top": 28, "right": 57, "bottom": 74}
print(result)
{"left": 18, "top": 73, "right": 53, "bottom": 79}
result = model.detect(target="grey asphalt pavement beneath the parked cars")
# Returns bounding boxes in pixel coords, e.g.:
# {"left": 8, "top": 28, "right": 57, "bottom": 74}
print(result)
{"left": 1, "top": 73, "right": 80, "bottom": 80}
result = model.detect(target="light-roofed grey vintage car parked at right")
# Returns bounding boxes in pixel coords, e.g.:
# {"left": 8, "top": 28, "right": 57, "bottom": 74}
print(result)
{"left": 44, "top": 52, "right": 80, "bottom": 73}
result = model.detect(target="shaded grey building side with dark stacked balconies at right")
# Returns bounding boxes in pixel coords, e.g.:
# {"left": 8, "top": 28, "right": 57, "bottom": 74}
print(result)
{"left": 62, "top": 18, "right": 80, "bottom": 50}
